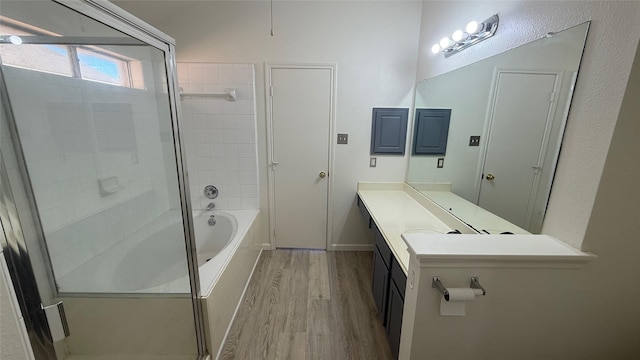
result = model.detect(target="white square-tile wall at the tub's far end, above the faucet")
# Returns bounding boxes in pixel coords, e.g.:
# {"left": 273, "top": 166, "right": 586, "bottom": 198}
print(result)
{"left": 178, "top": 63, "right": 260, "bottom": 210}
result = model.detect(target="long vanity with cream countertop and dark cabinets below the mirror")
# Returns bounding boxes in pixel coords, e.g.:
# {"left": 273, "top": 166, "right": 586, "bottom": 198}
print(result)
{"left": 357, "top": 183, "right": 475, "bottom": 359}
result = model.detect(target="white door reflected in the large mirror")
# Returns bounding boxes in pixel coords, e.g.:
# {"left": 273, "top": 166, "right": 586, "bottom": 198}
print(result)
{"left": 478, "top": 71, "right": 560, "bottom": 229}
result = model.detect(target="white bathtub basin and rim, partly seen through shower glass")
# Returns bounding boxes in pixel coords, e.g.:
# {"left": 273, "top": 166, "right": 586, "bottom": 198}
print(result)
{"left": 58, "top": 210, "right": 258, "bottom": 294}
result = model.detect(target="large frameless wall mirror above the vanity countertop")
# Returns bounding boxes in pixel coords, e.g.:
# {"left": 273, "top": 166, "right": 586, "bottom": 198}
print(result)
{"left": 406, "top": 22, "right": 590, "bottom": 233}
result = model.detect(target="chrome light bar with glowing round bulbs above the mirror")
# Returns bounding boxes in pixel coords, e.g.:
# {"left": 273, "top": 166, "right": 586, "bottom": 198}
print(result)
{"left": 431, "top": 14, "right": 498, "bottom": 58}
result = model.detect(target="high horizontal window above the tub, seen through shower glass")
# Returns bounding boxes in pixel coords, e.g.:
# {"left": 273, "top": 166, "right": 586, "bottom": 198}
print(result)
{"left": 0, "top": 16, "right": 144, "bottom": 89}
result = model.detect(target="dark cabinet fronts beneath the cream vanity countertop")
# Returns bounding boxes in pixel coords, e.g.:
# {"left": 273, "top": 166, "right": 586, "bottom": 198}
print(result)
{"left": 358, "top": 197, "right": 407, "bottom": 359}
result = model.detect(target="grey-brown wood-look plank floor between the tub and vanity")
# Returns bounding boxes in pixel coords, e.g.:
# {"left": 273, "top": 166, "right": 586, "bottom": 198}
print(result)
{"left": 221, "top": 249, "right": 392, "bottom": 360}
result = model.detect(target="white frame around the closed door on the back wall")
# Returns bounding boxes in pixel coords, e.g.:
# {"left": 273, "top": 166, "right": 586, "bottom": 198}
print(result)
{"left": 264, "top": 62, "right": 338, "bottom": 250}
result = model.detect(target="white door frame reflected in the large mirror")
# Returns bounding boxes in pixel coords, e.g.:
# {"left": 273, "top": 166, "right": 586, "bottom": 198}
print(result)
{"left": 474, "top": 67, "right": 566, "bottom": 228}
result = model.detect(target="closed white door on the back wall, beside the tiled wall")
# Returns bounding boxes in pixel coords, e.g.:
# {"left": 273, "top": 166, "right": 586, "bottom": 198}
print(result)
{"left": 267, "top": 65, "right": 334, "bottom": 249}
